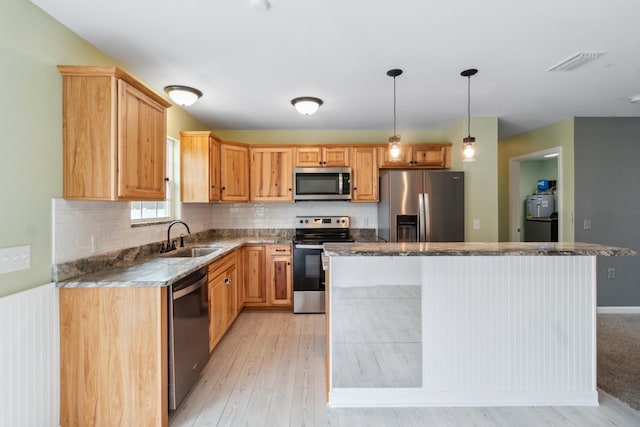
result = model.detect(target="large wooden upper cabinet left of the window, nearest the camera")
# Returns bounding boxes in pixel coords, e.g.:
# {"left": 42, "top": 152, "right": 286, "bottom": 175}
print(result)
{"left": 58, "top": 65, "right": 171, "bottom": 200}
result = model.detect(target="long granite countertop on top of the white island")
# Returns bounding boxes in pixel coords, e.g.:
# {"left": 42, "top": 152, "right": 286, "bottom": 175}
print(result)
{"left": 324, "top": 242, "right": 637, "bottom": 256}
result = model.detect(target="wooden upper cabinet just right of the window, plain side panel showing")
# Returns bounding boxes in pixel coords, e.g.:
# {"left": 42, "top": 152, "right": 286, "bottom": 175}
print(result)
{"left": 180, "top": 131, "right": 220, "bottom": 203}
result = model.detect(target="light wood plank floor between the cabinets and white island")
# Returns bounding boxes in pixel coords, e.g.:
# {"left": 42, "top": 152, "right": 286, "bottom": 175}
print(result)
{"left": 170, "top": 312, "right": 640, "bottom": 427}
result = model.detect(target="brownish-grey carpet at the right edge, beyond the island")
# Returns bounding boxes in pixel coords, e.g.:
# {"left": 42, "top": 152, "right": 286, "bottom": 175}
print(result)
{"left": 597, "top": 314, "right": 640, "bottom": 411}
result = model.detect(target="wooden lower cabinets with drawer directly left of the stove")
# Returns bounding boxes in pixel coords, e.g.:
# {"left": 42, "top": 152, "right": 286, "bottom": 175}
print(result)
{"left": 243, "top": 244, "right": 293, "bottom": 308}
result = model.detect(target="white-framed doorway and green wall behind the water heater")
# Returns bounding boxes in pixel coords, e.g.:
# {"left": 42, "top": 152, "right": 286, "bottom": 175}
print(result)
{"left": 509, "top": 147, "right": 564, "bottom": 242}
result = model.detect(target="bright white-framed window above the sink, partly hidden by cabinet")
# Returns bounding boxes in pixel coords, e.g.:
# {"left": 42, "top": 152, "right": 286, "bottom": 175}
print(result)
{"left": 131, "top": 137, "right": 178, "bottom": 224}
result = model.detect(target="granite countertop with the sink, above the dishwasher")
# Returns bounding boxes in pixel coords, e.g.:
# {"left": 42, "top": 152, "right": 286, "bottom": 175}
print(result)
{"left": 56, "top": 237, "right": 290, "bottom": 288}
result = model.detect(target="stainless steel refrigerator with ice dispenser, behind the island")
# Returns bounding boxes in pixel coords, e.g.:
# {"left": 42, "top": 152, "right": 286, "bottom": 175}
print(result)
{"left": 378, "top": 170, "right": 464, "bottom": 242}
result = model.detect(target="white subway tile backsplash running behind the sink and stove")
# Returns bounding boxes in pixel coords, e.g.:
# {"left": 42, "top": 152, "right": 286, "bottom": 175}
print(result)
{"left": 52, "top": 199, "right": 378, "bottom": 264}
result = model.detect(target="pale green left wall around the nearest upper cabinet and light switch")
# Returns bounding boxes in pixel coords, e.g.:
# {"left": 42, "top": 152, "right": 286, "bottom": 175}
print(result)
{"left": 0, "top": 0, "right": 206, "bottom": 297}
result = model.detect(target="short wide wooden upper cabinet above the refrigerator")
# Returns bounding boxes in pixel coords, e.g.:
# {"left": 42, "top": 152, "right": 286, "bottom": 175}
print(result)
{"left": 378, "top": 143, "right": 451, "bottom": 169}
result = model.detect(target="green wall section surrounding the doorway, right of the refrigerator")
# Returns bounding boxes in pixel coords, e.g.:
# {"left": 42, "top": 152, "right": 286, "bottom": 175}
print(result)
{"left": 498, "top": 118, "right": 574, "bottom": 242}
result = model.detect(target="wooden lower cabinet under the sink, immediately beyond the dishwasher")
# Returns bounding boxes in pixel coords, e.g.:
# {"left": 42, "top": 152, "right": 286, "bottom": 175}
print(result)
{"left": 208, "top": 251, "right": 238, "bottom": 351}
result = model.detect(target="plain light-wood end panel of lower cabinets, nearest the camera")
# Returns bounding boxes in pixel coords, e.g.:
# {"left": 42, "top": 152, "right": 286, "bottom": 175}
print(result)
{"left": 59, "top": 287, "right": 169, "bottom": 426}
